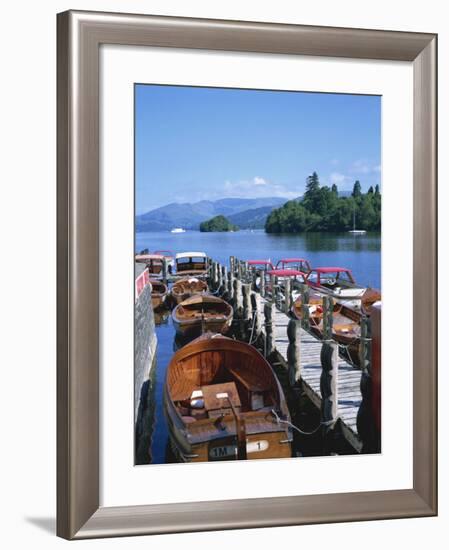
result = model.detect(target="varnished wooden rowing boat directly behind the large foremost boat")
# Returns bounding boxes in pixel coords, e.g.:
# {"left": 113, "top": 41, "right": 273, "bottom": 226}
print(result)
{"left": 172, "top": 294, "right": 234, "bottom": 338}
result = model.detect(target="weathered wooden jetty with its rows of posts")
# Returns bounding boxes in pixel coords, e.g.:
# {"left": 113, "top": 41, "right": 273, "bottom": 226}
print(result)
{"left": 206, "top": 257, "right": 380, "bottom": 452}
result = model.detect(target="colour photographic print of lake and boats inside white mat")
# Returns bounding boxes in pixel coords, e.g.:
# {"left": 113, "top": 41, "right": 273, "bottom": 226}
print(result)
{"left": 134, "top": 84, "right": 382, "bottom": 465}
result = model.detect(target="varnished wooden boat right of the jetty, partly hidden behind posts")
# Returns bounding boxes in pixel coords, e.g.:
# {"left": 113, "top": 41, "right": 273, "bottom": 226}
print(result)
{"left": 292, "top": 288, "right": 381, "bottom": 366}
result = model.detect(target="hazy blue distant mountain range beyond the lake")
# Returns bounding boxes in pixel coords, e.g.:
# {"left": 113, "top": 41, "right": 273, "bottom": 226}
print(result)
{"left": 136, "top": 197, "right": 285, "bottom": 232}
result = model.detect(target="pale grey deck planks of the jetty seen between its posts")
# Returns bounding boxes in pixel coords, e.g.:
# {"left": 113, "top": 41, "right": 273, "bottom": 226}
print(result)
{"left": 261, "top": 299, "right": 362, "bottom": 451}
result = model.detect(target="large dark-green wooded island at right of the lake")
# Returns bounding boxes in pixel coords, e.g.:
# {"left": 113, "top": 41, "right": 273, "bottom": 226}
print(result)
{"left": 265, "top": 172, "right": 381, "bottom": 233}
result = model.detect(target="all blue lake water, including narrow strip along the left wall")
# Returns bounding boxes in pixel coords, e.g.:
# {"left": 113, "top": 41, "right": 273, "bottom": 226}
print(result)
{"left": 135, "top": 230, "right": 381, "bottom": 464}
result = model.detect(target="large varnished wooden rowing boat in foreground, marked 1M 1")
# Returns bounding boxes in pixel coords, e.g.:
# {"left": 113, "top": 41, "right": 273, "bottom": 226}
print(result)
{"left": 164, "top": 333, "right": 292, "bottom": 462}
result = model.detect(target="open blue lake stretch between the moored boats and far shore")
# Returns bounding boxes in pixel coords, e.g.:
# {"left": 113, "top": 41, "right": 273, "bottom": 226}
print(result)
{"left": 136, "top": 230, "right": 381, "bottom": 289}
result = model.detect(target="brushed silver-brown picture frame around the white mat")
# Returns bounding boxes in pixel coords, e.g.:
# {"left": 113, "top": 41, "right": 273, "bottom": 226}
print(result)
{"left": 57, "top": 11, "right": 437, "bottom": 539}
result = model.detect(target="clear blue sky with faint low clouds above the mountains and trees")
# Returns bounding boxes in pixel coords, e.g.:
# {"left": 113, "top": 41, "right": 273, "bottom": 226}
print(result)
{"left": 135, "top": 84, "right": 381, "bottom": 214}
